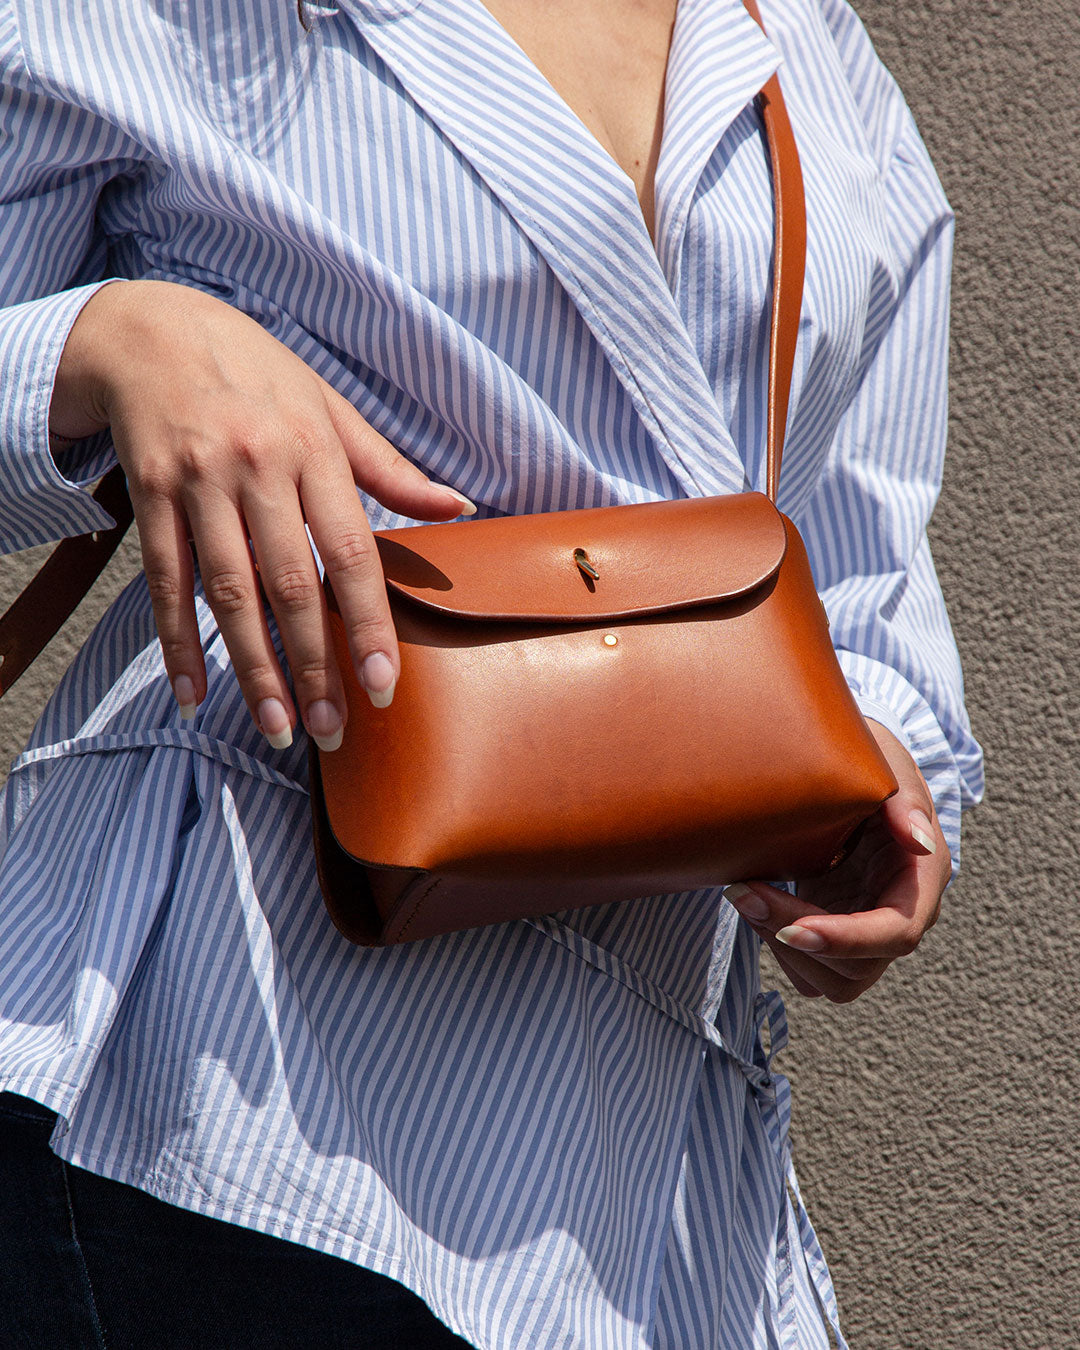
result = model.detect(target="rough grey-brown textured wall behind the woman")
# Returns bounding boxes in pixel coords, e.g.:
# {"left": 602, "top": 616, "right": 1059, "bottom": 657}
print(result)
{"left": 0, "top": 0, "right": 1080, "bottom": 1350}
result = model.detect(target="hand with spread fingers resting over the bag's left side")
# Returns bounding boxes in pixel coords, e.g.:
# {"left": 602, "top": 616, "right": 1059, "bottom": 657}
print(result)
{"left": 50, "top": 281, "right": 475, "bottom": 749}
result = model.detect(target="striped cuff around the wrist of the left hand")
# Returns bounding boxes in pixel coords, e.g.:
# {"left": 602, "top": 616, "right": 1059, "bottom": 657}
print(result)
{"left": 0, "top": 277, "right": 122, "bottom": 552}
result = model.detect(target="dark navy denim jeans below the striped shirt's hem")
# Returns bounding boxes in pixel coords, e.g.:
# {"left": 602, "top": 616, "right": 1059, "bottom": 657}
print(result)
{"left": 0, "top": 1092, "right": 468, "bottom": 1350}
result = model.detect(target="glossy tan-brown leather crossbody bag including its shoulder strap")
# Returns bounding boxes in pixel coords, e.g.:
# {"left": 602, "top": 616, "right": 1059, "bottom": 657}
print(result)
{"left": 0, "top": 0, "right": 898, "bottom": 946}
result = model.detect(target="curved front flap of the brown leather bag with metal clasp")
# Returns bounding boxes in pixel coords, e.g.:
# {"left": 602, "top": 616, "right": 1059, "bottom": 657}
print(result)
{"left": 375, "top": 493, "right": 787, "bottom": 624}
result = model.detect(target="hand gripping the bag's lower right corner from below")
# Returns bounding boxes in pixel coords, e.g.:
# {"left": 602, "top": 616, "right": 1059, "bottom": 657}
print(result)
{"left": 725, "top": 718, "right": 952, "bottom": 1003}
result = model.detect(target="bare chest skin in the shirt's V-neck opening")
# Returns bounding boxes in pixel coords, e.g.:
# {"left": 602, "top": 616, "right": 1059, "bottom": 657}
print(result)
{"left": 475, "top": 0, "right": 676, "bottom": 235}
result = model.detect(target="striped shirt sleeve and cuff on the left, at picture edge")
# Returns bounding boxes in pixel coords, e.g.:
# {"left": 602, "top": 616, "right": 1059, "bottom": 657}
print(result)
{"left": 0, "top": 5, "right": 140, "bottom": 554}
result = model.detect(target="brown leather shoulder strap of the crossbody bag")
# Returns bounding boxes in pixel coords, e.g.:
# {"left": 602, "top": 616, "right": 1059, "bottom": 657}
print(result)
{"left": 0, "top": 10, "right": 806, "bottom": 695}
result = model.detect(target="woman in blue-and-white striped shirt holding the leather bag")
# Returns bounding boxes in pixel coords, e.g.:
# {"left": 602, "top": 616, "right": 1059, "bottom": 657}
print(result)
{"left": 0, "top": 0, "right": 981, "bottom": 1350}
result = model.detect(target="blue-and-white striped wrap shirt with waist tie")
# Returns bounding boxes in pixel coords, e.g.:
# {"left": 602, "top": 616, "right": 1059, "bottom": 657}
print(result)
{"left": 0, "top": 0, "right": 981, "bottom": 1350}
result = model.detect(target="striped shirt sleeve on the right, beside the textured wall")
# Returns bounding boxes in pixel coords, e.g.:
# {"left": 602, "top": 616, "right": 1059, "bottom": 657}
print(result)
{"left": 797, "top": 0, "right": 984, "bottom": 878}
